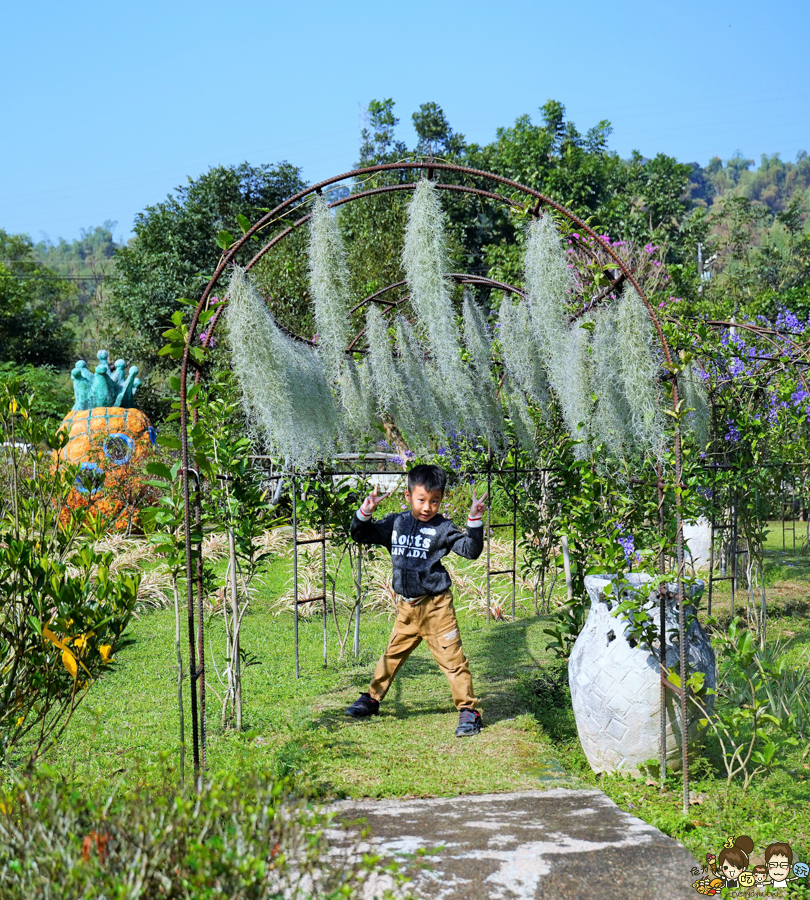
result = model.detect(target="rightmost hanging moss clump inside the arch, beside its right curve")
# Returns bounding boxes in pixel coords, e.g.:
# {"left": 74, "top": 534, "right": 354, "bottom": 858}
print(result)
{"left": 616, "top": 285, "right": 664, "bottom": 456}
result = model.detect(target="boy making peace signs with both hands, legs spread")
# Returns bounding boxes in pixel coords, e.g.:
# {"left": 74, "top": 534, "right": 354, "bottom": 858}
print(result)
{"left": 346, "top": 465, "right": 487, "bottom": 737}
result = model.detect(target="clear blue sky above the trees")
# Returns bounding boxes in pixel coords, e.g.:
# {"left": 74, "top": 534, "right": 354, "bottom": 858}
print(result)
{"left": 0, "top": 0, "right": 810, "bottom": 246}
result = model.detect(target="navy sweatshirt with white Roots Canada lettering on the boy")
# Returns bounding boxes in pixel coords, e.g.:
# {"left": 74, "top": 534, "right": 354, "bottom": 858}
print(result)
{"left": 352, "top": 509, "right": 484, "bottom": 600}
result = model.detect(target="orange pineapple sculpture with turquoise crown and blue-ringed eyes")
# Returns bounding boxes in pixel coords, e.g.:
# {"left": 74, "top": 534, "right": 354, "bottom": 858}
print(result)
{"left": 60, "top": 350, "right": 156, "bottom": 531}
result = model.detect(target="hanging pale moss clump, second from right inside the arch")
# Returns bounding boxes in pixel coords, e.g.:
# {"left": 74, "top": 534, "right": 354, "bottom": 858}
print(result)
{"left": 591, "top": 307, "right": 634, "bottom": 454}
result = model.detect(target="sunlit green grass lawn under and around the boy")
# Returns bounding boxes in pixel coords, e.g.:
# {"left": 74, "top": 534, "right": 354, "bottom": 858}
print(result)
{"left": 33, "top": 524, "right": 810, "bottom": 859}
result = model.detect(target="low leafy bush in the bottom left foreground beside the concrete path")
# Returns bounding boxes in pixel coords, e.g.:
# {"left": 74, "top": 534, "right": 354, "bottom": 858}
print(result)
{"left": 0, "top": 774, "right": 397, "bottom": 900}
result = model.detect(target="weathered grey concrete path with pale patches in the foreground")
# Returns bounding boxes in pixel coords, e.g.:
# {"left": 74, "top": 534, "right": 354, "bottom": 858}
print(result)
{"left": 330, "top": 788, "right": 697, "bottom": 900}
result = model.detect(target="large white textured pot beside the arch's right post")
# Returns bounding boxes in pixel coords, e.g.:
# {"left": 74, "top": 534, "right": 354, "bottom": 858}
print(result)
{"left": 568, "top": 574, "right": 717, "bottom": 772}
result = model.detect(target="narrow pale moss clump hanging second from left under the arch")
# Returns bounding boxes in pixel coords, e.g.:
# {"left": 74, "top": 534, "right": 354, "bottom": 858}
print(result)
{"left": 308, "top": 196, "right": 351, "bottom": 381}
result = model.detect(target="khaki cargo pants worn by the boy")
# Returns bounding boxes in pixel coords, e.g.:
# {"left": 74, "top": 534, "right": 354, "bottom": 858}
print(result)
{"left": 368, "top": 591, "right": 478, "bottom": 709}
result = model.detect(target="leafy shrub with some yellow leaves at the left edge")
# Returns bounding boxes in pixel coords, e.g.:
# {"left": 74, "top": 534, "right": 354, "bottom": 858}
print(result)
{"left": 0, "top": 382, "right": 140, "bottom": 761}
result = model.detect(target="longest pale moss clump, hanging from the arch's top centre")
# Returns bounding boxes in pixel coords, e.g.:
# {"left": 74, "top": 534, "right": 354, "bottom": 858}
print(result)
{"left": 402, "top": 181, "right": 478, "bottom": 420}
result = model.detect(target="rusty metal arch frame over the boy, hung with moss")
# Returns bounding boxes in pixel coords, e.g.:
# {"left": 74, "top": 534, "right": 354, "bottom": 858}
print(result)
{"left": 180, "top": 159, "right": 689, "bottom": 814}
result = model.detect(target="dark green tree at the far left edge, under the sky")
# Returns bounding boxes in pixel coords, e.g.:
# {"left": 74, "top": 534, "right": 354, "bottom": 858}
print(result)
{"left": 0, "top": 229, "right": 73, "bottom": 367}
